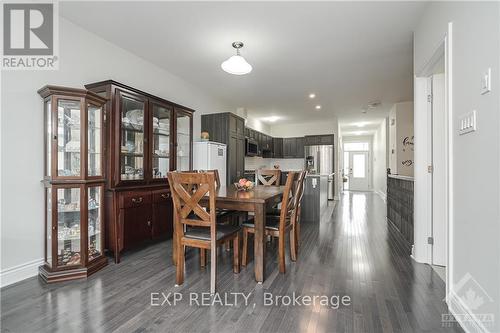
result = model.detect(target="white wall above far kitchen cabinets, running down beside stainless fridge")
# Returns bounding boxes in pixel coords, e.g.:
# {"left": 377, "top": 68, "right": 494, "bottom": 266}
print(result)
{"left": 271, "top": 117, "right": 342, "bottom": 200}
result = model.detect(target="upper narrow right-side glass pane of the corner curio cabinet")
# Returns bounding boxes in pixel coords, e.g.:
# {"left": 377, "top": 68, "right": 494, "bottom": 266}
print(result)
{"left": 87, "top": 103, "right": 103, "bottom": 177}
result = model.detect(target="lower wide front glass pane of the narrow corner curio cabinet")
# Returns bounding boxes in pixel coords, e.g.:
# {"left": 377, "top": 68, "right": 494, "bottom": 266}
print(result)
{"left": 57, "top": 187, "right": 81, "bottom": 267}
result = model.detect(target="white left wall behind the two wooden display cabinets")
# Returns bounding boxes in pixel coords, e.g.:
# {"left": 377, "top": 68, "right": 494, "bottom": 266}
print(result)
{"left": 0, "top": 18, "right": 227, "bottom": 285}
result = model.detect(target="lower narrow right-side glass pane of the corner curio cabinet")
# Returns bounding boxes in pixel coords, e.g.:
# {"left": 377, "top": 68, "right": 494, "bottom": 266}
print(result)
{"left": 87, "top": 185, "right": 103, "bottom": 261}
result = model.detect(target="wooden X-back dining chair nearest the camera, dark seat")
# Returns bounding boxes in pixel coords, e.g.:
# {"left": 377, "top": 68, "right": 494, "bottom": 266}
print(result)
{"left": 168, "top": 172, "right": 241, "bottom": 293}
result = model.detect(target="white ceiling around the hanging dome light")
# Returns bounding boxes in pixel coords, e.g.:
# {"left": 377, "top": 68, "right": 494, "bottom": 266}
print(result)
{"left": 60, "top": 2, "right": 426, "bottom": 126}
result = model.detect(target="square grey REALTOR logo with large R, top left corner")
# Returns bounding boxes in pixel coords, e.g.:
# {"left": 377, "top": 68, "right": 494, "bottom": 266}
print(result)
{"left": 2, "top": 3, "right": 58, "bottom": 70}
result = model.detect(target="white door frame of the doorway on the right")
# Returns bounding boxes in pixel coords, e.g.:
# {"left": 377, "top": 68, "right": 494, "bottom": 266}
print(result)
{"left": 412, "top": 22, "right": 454, "bottom": 302}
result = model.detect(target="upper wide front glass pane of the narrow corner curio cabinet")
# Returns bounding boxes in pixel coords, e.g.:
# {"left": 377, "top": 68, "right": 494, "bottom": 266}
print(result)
{"left": 57, "top": 99, "right": 81, "bottom": 177}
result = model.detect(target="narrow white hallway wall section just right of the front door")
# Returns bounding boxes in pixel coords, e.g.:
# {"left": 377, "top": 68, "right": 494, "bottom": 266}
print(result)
{"left": 372, "top": 119, "right": 387, "bottom": 198}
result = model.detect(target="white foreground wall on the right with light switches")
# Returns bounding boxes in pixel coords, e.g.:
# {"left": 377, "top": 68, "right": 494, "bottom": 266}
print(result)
{"left": 414, "top": 2, "right": 500, "bottom": 332}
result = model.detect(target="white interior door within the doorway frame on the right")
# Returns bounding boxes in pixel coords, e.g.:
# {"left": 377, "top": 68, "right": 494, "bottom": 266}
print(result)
{"left": 431, "top": 74, "right": 447, "bottom": 266}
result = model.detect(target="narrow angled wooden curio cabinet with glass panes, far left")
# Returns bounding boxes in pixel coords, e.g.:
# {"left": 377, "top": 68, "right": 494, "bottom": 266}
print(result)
{"left": 38, "top": 86, "right": 107, "bottom": 282}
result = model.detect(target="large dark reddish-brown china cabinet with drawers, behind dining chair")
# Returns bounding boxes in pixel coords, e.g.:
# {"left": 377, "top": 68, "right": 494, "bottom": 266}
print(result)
{"left": 85, "top": 80, "right": 194, "bottom": 263}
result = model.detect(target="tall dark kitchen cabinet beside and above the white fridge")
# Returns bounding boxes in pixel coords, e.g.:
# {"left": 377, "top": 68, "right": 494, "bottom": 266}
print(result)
{"left": 201, "top": 112, "right": 245, "bottom": 185}
